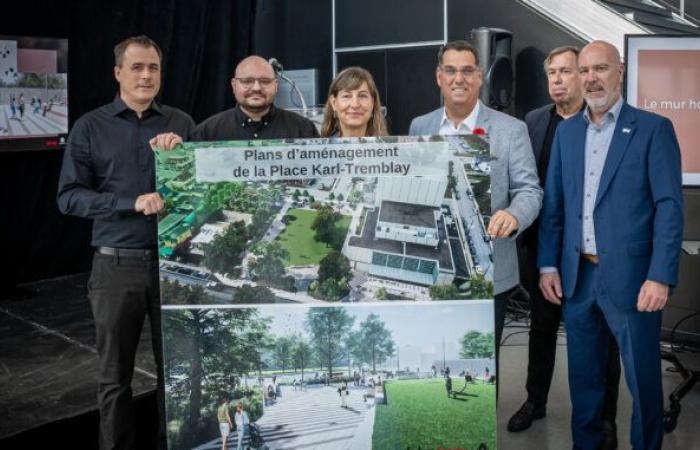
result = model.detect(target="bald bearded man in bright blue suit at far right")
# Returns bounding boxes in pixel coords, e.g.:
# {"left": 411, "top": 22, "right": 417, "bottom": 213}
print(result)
{"left": 538, "top": 41, "right": 683, "bottom": 450}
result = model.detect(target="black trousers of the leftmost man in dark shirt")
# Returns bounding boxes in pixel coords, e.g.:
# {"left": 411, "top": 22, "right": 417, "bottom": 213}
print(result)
{"left": 88, "top": 253, "right": 165, "bottom": 450}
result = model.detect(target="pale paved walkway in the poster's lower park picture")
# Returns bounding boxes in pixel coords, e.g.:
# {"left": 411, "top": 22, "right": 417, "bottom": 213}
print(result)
{"left": 197, "top": 386, "right": 373, "bottom": 450}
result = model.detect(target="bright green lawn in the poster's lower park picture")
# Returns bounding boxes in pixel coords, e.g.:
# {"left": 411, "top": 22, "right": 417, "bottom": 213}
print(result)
{"left": 372, "top": 377, "right": 496, "bottom": 450}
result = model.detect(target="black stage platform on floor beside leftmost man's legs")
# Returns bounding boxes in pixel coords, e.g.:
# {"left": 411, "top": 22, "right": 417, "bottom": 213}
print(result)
{"left": 0, "top": 273, "right": 158, "bottom": 449}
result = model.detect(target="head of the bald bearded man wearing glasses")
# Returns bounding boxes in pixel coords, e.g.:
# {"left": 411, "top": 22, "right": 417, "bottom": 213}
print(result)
{"left": 231, "top": 55, "right": 277, "bottom": 120}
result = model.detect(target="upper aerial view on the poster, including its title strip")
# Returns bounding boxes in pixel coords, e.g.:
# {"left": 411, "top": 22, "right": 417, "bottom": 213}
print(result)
{"left": 157, "top": 135, "right": 493, "bottom": 305}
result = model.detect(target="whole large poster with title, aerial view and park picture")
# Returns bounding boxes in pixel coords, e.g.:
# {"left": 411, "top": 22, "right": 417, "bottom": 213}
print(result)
{"left": 157, "top": 136, "right": 496, "bottom": 449}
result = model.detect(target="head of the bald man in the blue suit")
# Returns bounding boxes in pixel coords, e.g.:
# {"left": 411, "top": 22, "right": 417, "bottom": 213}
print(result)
{"left": 578, "top": 41, "right": 624, "bottom": 120}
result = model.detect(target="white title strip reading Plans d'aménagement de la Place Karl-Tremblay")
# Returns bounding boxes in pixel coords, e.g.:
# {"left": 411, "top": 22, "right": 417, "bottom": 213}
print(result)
{"left": 195, "top": 142, "right": 450, "bottom": 183}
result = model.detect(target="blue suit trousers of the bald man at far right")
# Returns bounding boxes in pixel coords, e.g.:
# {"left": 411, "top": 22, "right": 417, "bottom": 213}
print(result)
{"left": 563, "top": 261, "right": 664, "bottom": 450}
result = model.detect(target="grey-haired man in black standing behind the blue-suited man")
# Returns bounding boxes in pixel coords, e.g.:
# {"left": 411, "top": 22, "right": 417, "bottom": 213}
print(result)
{"left": 508, "top": 47, "right": 620, "bottom": 448}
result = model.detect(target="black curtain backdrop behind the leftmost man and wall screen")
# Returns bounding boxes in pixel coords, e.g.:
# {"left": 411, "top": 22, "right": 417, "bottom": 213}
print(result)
{"left": 0, "top": 0, "right": 256, "bottom": 297}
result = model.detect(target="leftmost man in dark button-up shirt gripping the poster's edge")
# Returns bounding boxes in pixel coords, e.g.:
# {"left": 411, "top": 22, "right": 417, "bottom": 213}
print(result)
{"left": 58, "top": 36, "right": 194, "bottom": 449}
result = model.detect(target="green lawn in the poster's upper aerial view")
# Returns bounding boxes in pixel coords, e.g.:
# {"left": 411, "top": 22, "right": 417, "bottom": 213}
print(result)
{"left": 277, "top": 208, "right": 351, "bottom": 266}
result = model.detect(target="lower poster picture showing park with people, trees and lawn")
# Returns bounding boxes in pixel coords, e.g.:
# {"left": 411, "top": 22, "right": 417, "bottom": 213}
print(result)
{"left": 163, "top": 302, "right": 496, "bottom": 450}
